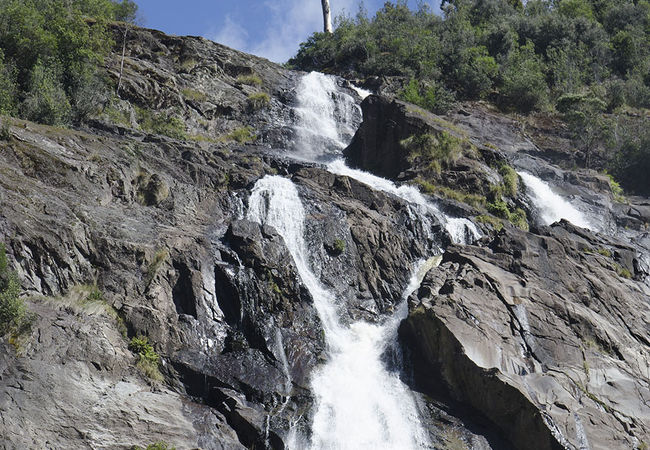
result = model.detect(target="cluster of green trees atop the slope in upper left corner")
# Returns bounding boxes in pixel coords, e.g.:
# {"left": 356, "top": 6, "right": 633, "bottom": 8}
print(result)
{"left": 0, "top": 0, "right": 137, "bottom": 124}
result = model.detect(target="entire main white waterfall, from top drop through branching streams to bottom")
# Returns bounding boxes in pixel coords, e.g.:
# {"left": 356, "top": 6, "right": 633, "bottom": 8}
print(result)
{"left": 247, "top": 73, "right": 480, "bottom": 450}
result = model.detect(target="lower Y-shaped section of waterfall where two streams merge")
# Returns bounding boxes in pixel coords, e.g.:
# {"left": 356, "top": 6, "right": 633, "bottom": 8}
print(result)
{"left": 248, "top": 176, "right": 428, "bottom": 449}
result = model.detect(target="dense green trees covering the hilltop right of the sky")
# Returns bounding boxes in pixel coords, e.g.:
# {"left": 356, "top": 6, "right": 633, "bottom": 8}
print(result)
{"left": 289, "top": 0, "right": 650, "bottom": 113}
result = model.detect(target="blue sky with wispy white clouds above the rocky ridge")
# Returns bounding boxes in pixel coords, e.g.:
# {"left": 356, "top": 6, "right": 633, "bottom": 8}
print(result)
{"left": 135, "top": 0, "right": 440, "bottom": 62}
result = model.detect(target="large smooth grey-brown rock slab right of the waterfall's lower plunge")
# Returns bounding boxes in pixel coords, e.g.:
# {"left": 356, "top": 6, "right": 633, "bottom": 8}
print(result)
{"left": 402, "top": 222, "right": 650, "bottom": 449}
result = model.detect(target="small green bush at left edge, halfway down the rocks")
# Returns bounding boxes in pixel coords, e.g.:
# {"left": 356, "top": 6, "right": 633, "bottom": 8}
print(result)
{"left": 0, "top": 243, "right": 29, "bottom": 336}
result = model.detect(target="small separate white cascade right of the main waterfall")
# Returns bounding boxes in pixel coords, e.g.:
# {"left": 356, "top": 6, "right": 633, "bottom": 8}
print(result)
{"left": 517, "top": 171, "right": 595, "bottom": 230}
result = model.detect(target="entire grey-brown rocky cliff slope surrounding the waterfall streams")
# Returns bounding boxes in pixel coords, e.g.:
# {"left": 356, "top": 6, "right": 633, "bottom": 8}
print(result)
{"left": 0, "top": 23, "right": 650, "bottom": 449}
